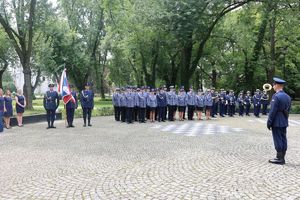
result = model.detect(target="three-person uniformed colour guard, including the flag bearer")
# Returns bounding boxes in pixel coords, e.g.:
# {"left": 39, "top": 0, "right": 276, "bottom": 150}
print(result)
{"left": 44, "top": 83, "right": 94, "bottom": 129}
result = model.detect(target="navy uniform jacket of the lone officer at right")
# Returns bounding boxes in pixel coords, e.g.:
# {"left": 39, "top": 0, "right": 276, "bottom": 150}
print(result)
{"left": 267, "top": 90, "right": 291, "bottom": 127}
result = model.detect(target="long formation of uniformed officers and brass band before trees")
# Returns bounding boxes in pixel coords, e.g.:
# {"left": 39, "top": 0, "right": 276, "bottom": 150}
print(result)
{"left": 112, "top": 86, "right": 269, "bottom": 123}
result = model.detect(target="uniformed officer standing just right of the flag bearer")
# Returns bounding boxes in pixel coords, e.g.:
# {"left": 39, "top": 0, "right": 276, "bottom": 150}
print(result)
{"left": 80, "top": 83, "right": 94, "bottom": 127}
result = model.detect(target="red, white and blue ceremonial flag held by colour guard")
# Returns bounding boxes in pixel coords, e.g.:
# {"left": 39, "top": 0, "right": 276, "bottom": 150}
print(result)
{"left": 58, "top": 69, "right": 75, "bottom": 105}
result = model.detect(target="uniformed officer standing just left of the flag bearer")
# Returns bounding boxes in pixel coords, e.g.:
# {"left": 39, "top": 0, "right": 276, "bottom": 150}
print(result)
{"left": 43, "top": 83, "right": 59, "bottom": 129}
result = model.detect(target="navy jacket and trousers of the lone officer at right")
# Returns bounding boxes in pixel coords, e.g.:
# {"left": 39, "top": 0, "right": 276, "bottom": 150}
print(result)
{"left": 267, "top": 90, "right": 291, "bottom": 154}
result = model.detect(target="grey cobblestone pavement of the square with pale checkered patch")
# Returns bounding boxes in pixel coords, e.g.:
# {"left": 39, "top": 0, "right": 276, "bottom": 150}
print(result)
{"left": 0, "top": 115, "right": 300, "bottom": 200}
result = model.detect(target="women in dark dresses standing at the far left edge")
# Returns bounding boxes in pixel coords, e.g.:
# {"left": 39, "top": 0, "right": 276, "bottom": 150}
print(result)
{"left": 0, "top": 88, "right": 26, "bottom": 132}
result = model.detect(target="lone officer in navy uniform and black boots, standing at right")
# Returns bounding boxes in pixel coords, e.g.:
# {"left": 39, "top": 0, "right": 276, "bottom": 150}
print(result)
{"left": 267, "top": 77, "right": 291, "bottom": 164}
